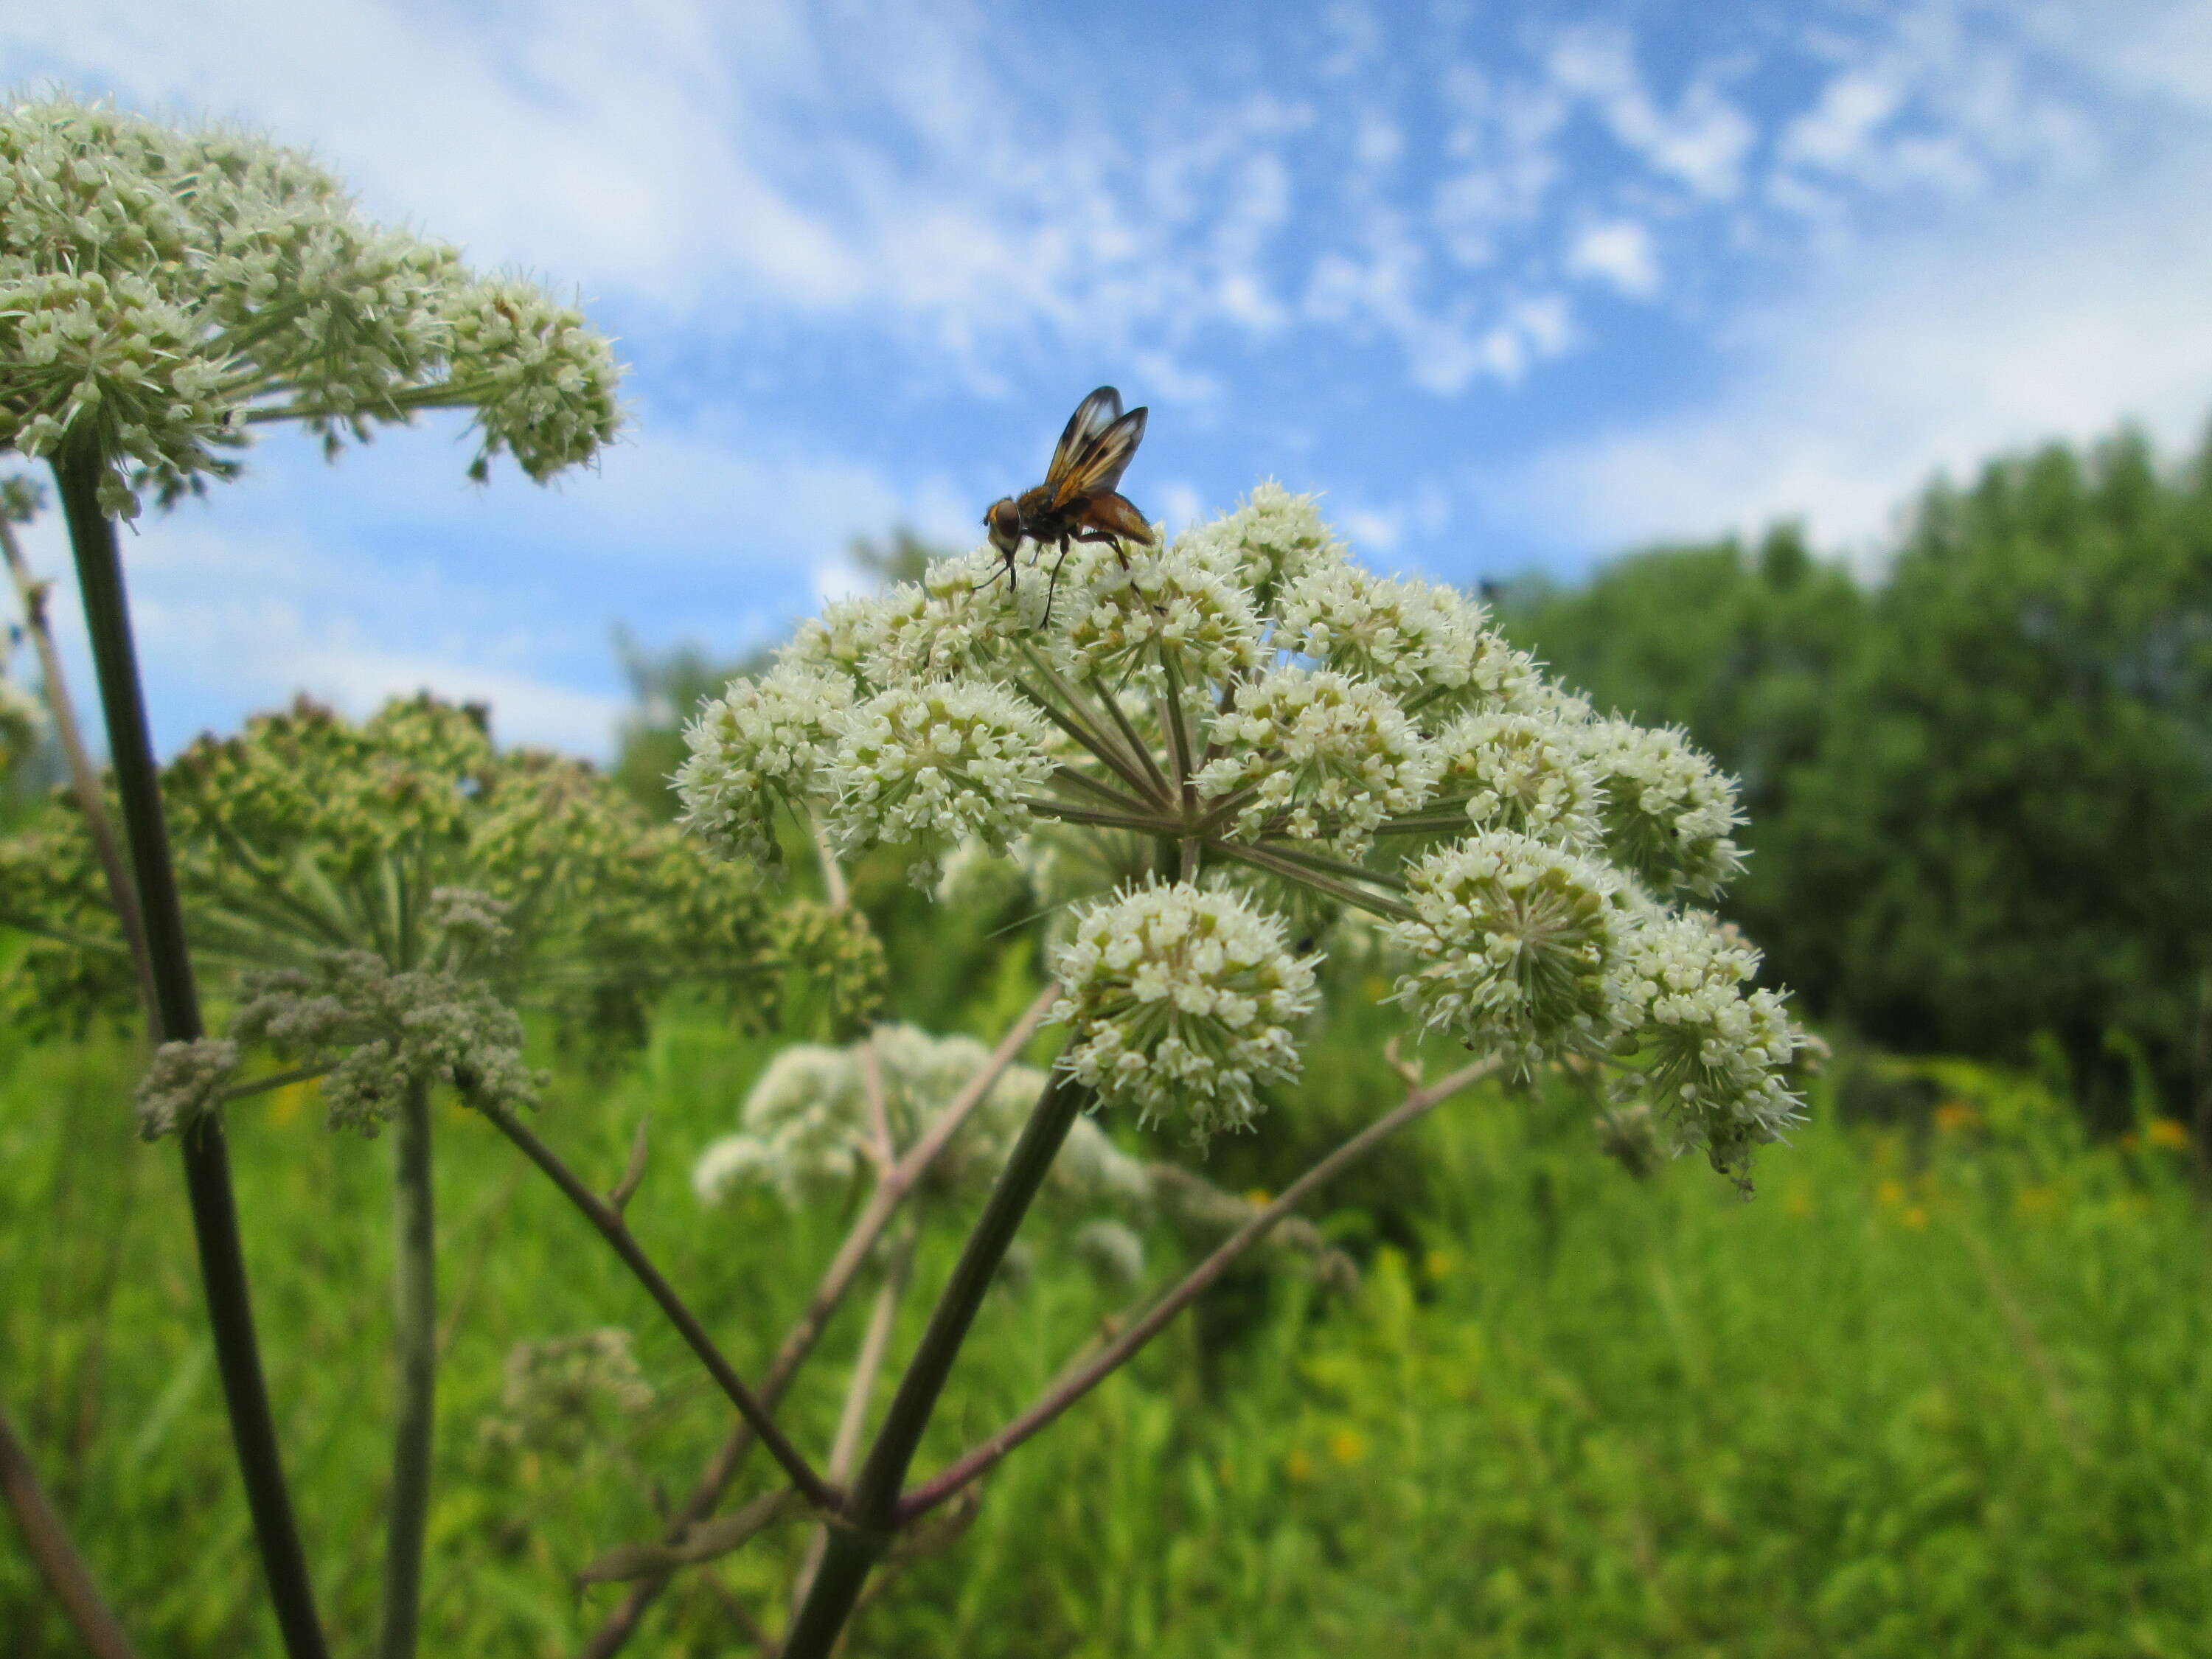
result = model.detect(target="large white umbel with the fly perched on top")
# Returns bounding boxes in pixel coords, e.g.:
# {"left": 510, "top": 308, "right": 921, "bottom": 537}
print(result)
{"left": 679, "top": 484, "right": 1796, "bottom": 1168}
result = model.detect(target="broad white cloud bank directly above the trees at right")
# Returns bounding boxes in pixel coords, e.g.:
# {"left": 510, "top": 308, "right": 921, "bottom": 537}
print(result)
{"left": 1478, "top": 148, "right": 2212, "bottom": 571}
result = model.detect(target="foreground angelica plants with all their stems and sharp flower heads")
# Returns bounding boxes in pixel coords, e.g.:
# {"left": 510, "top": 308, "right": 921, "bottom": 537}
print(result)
{"left": 0, "top": 91, "right": 1803, "bottom": 1659}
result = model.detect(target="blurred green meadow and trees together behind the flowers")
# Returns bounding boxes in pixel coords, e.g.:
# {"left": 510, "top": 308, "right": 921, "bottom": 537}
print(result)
{"left": 13, "top": 425, "right": 2212, "bottom": 1659}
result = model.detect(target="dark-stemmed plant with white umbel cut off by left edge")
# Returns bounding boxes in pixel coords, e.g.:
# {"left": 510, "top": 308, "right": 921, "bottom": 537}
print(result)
{"left": 0, "top": 97, "right": 619, "bottom": 1659}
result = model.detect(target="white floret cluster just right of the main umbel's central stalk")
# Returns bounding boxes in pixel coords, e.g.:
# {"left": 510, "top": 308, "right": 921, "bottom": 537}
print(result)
{"left": 1199, "top": 666, "right": 1436, "bottom": 858}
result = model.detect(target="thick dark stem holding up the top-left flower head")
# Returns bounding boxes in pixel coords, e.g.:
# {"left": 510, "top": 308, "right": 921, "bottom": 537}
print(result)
{"left": 53, "top": 449, "right": 327, "bottom": 1659}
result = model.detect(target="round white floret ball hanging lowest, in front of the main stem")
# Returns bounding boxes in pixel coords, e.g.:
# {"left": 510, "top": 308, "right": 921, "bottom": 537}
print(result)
{"left": 1053, "top": 880, "right": 1318, "bottom": 1141}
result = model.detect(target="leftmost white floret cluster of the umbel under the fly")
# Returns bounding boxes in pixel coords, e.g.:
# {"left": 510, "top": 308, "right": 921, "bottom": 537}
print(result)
{"left": 675, "top": 661, "right": 852, "bottom": 865}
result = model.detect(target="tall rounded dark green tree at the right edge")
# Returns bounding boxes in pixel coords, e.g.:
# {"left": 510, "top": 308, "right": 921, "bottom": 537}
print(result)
{"left": 1763, "top": 431, "right": 2212, "bottom": 1117}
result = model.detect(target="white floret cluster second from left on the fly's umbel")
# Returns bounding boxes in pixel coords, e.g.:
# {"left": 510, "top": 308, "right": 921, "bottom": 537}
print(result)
{"left": 825, "top": 679, "right": 1053, "bottom": 887}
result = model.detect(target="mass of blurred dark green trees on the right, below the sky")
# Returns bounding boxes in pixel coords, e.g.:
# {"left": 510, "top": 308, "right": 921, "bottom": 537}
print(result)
{"left": 1500, "top": 434, "right": 2212, "bottom": 1124}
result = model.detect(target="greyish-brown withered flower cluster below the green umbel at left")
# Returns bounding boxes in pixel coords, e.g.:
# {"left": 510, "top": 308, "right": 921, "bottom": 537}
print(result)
{"left": 230, "top": 951, "right": 540, "bottom": 1137}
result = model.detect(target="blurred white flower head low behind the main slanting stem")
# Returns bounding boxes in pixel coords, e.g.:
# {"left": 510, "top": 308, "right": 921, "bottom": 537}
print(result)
{"left": 692, "top": 1024, "right": 1150, "bottom": 1208}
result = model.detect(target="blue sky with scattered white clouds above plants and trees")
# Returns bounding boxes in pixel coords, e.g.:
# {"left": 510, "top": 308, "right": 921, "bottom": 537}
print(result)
{"left": 0, "top": 0, "right": 2212, "bottom": 752}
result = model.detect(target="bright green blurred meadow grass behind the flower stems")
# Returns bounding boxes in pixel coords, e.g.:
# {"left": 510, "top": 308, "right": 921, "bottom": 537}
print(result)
{"left": 0, "top": 1009, "right": 2212, "bottom": 1659}
